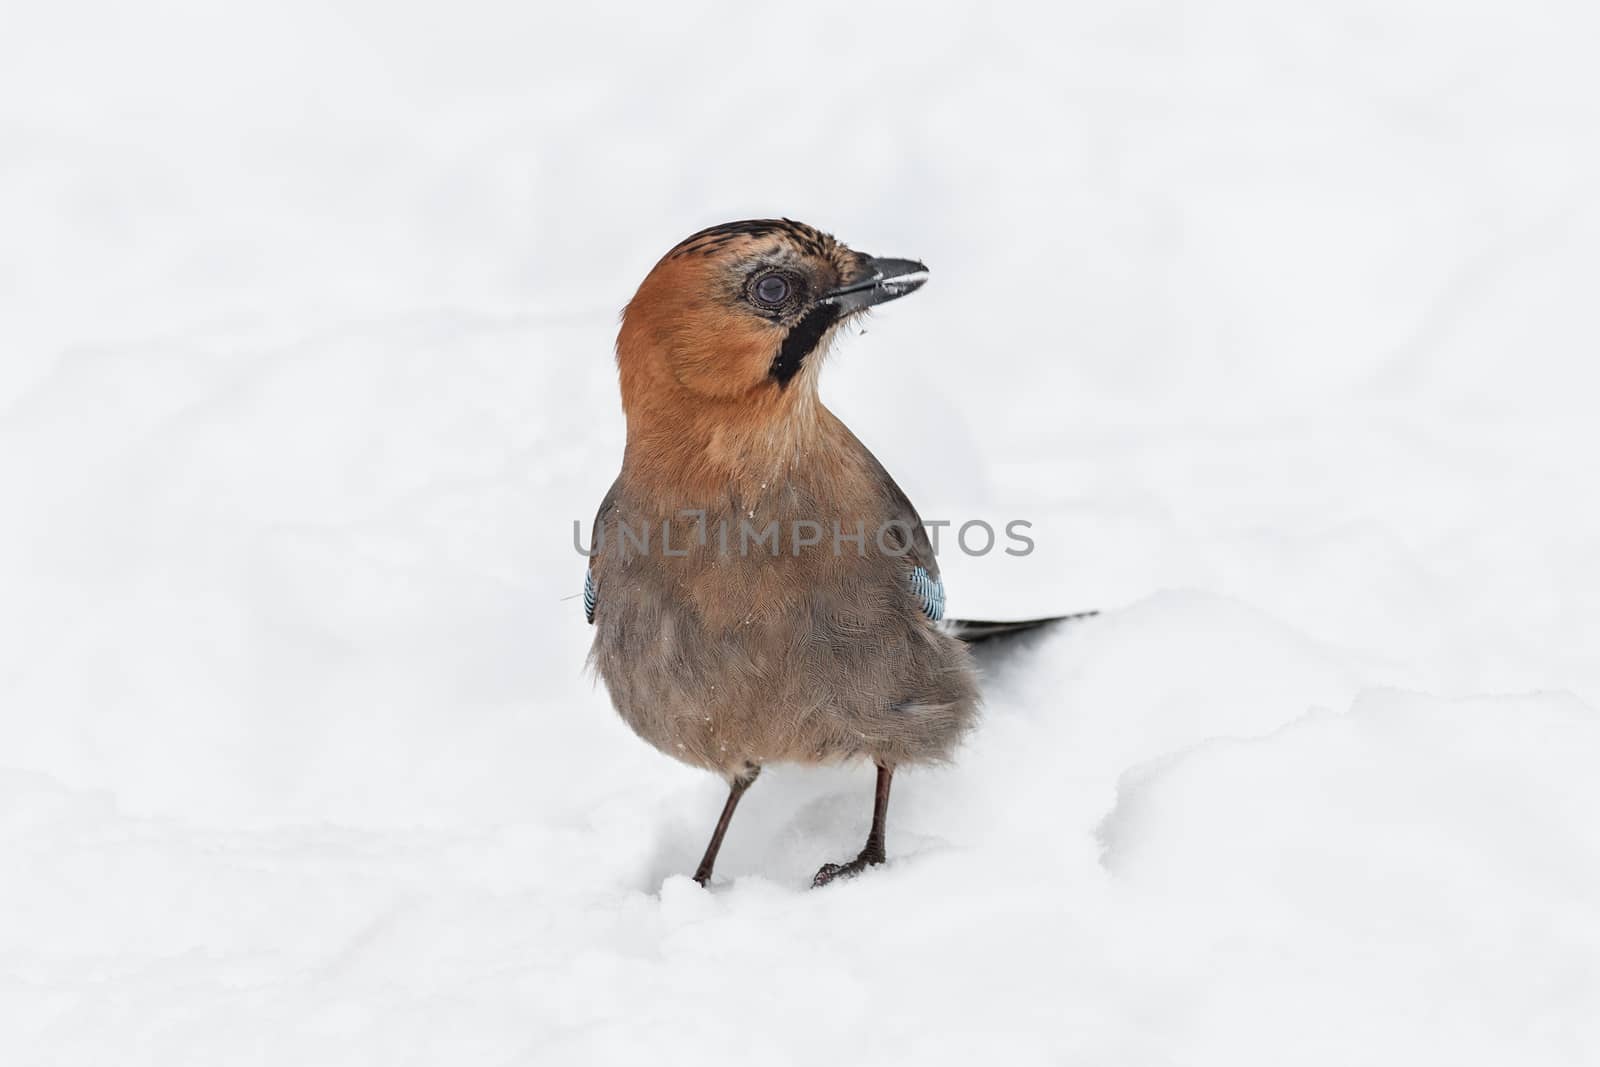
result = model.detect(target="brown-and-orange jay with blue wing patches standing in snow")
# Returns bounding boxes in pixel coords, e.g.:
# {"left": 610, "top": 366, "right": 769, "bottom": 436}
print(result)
{"left": 582, "top": 219, "right": 1053, "bottom": 886}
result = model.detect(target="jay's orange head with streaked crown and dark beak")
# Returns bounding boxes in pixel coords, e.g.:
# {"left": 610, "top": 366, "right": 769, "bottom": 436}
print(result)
{"left": 618, "top": 219, "right": 928, "bottom": 418}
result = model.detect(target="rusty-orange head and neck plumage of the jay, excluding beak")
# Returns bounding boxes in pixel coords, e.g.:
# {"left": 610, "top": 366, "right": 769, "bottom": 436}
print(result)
{"left": 616, "top": 219, "right": 883, "bottom": 509}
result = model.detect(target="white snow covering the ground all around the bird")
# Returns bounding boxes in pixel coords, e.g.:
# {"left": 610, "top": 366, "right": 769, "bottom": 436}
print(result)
{"left": 0, "top": 0, "right": 1600, "bottom": 1067}
